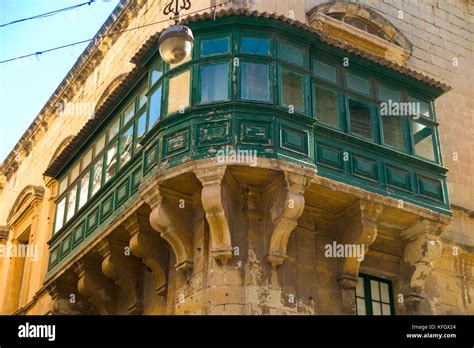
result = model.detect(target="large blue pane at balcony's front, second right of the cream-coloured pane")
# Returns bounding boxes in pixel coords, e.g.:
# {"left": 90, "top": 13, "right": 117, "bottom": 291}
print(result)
{"left": 240, "top": 63, "right": 270, "bottom": 101}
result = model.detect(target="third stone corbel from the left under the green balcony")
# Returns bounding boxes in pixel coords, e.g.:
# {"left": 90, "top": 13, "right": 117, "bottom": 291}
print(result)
{"left": 97, "top": 238, "right": 143, "bottom": 314}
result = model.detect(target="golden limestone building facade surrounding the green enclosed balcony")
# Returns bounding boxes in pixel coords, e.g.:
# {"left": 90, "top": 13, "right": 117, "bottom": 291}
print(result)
{"left": 0, "top": 0, "right": 474, "bottom": 314}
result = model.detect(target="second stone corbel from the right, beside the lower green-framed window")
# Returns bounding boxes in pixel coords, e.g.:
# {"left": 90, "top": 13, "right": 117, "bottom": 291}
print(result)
{"left": 337, "top": 200, "right": 383, "bottom": 314}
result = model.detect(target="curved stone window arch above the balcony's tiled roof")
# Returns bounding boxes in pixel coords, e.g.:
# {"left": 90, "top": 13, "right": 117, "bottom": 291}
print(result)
{"left": 307, "top": 1, "right": 413, "bottom": 64}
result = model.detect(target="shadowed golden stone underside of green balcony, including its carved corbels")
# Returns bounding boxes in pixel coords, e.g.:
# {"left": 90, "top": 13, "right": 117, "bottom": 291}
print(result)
{"left": 39, "top": 158, "right": 450, "bottom": 314}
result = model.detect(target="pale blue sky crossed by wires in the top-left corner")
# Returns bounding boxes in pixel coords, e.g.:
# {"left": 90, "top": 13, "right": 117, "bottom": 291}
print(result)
{"left": 0, "top": 0, "right": 119, "bottom": 164}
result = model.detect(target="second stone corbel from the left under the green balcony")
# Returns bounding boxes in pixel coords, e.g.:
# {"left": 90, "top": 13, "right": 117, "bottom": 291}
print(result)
{"left": 74, "top": 259, "right": 117, "bottom": 315}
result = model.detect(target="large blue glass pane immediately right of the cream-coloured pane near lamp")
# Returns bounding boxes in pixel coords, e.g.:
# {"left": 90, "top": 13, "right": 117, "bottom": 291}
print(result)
{"left": 200, "top": 63, "right": 229, "bottom": 103}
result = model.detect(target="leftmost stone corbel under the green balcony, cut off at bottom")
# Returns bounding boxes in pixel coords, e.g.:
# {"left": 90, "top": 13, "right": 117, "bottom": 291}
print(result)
{"left": 46, "top": 279, "right": 86, "bottom": 315}
